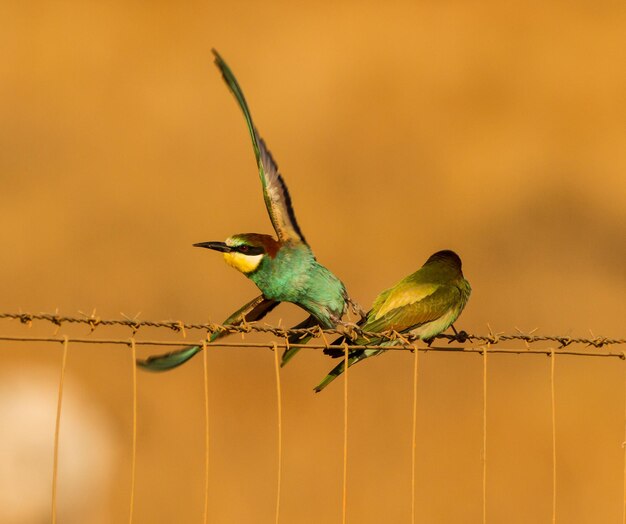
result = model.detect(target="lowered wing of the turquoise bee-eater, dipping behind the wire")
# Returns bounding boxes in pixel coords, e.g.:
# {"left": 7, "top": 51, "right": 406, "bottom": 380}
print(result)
{"left": 137, "top": 295, "right": 280, "bottom": 371}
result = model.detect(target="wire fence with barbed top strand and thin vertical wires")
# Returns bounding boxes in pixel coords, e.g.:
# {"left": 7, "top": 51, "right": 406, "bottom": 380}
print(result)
{"left": 0, "top": 312, "right": 626, "bottom": 524}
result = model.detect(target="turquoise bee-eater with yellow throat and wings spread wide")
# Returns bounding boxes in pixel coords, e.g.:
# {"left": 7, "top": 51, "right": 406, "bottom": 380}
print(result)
{"left": 138, "top": 50, "right": 357, "bottom": 371}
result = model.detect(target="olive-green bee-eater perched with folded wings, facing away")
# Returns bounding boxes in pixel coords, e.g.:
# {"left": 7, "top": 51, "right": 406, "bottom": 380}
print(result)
{"left": 315, "top": 250, "right": 472, "bottom": 392}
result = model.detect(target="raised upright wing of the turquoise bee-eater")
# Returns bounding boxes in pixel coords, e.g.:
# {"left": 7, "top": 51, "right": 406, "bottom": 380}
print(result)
{"left": 213, "top": 49, "right": 306, "bottom": 243}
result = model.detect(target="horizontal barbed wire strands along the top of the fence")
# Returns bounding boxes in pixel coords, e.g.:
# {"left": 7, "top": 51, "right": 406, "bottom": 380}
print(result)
{"left": 0, "top": 312, "right": 626, "bottom": 359}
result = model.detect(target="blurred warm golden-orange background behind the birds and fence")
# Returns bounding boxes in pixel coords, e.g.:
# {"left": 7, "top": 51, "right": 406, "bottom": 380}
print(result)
{"left": 0, "top": 1, "right": 626, "bottom": 524}
